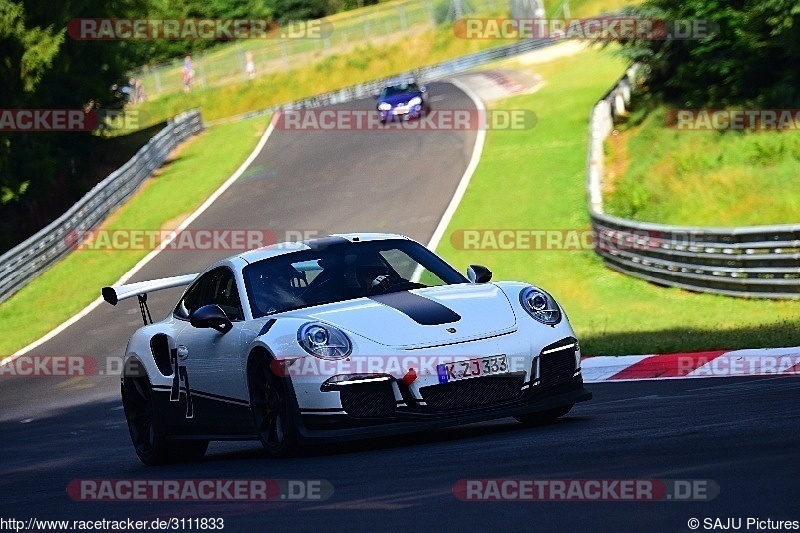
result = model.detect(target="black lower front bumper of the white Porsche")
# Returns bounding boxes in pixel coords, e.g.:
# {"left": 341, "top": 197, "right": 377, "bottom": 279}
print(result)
{"left": 296, "top": 336, "right": 592, "bottom": 441}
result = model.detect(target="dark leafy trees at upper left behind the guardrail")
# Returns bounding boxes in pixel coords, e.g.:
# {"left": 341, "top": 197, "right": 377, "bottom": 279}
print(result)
{"left": 0, "top": 0, "right": 144, "bottom": 248}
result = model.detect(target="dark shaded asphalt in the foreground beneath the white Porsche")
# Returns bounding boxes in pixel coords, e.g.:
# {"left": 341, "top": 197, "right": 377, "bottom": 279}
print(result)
{"left": 0, "top": 378, "right": 800, "bottom": 531}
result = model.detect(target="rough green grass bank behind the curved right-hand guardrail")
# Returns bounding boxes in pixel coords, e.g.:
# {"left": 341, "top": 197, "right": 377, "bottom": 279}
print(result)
{"left": 606, "top": 106, "right": 800, "bottom": 226}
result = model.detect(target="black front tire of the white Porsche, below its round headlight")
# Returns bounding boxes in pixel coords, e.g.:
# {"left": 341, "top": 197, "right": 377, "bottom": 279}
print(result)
{"left": 247, "top": 356, "right": 297, "bottom": 457}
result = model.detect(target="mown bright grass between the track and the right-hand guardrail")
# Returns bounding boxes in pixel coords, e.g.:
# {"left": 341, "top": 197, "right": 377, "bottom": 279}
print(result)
{"left": 438, "top": 45, "right": 800, "bottom": 355}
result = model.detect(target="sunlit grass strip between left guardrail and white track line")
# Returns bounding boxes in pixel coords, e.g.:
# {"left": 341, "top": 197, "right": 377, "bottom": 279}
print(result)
{"left": 0, "top": 117, "right": 270, "bottom": 358}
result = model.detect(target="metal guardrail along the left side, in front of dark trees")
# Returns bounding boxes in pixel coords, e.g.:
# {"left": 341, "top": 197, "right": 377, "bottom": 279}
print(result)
{"left": 0, "top": 110, "right": 203, "bottom": 302}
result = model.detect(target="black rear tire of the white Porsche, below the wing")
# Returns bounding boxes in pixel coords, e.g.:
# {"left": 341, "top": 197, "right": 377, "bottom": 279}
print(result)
{"left": 122, "top": 377, "right": 208, "bottom": 466}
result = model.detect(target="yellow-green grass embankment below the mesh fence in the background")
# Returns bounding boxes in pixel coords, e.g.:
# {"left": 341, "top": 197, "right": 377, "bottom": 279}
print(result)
{"left": 138, "top": 0, "right": 638, "bottom": 122}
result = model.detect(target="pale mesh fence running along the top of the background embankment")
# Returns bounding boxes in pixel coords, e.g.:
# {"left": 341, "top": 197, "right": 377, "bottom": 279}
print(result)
{"left": 132, "top": 0, "right": 508, "bottom": 96}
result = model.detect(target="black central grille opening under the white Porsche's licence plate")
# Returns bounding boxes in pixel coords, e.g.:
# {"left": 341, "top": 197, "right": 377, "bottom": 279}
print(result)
{"left": 419, "top": 372, "right": 525, "bottom": 411}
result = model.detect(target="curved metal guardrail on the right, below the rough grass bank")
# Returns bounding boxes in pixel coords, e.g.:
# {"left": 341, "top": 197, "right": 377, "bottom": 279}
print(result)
{"left": 586, "top": 67, "right": 800, "bottom": 298}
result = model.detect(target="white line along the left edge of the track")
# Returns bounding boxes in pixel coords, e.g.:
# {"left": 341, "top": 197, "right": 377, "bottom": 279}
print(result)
{"left": 0, "top": 121, "right": 275, "bottom": 365}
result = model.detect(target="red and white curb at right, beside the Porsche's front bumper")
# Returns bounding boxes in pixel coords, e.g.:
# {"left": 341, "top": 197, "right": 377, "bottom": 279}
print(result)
{"left": 581, "top": 346, "right": 800, "bottom": 383}
